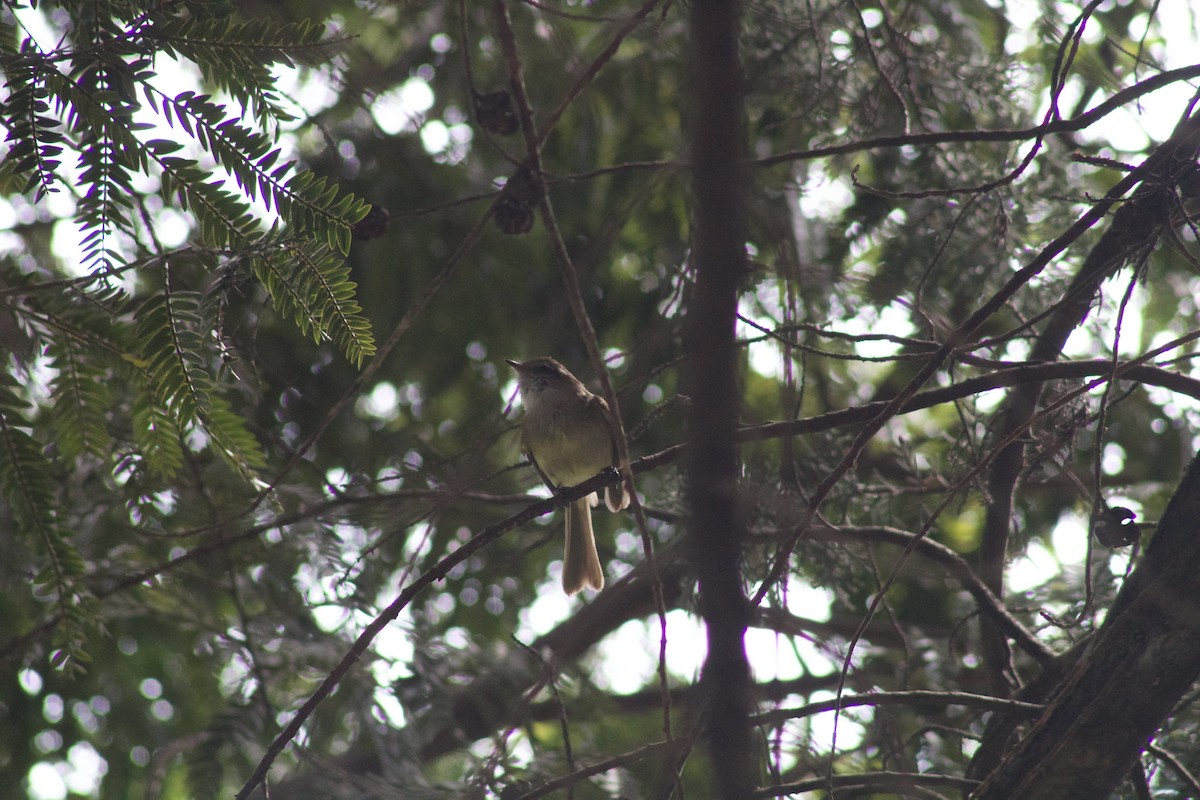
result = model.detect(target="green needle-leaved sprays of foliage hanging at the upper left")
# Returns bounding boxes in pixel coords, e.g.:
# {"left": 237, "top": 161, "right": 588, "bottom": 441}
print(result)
{"left": 0, "top": 0, "right": 374, "bottom": 671}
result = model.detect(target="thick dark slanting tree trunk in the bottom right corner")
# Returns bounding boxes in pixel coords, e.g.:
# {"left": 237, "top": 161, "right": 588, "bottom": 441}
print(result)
{"left": 972, "top": 456, "right": 1200, "bottom": 800}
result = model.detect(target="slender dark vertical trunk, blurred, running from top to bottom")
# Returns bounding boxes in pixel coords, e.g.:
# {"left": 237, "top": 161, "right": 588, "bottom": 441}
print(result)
{"left": 686, "top": 0, "right": 755, "bottom": 800}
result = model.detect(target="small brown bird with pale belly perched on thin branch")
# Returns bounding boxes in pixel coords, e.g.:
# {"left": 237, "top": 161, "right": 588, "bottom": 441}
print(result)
{"left": 508, "top": 357, "right": 629, "bottom": 595}
